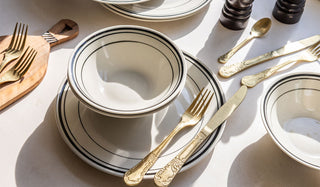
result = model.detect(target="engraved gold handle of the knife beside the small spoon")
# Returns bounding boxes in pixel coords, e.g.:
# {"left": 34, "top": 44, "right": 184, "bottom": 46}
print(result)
{"left": 219, "top": 52, "right": 279, "bottom": 78}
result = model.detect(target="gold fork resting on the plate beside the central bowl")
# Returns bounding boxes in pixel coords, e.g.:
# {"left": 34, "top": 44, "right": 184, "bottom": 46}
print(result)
{"left": 124, "top": 89, "right": 213, "bottom": 186}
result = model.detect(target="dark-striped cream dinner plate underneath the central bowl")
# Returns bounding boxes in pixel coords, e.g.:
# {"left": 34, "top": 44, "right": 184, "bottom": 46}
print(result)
{"left": 56, "top": 53, "right": 225, "bottom": 178}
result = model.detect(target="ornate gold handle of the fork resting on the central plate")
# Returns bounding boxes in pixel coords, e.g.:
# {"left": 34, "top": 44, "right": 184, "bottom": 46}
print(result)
{"left": 123, "top": 122, "right": 183, "bottom": 186}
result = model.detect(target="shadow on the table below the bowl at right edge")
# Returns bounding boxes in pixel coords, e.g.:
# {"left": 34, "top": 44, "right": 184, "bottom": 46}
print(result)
{"left": 228, "top": 134, "right": 320, "bottom": 187}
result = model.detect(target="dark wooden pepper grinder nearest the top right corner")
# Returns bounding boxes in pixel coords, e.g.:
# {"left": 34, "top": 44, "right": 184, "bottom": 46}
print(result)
{"left": 272, "top": 0, "right": 306, "bottom": 24}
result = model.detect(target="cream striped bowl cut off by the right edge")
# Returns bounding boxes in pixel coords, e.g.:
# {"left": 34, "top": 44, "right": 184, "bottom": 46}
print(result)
{"left": 262, "top": 73, "right": 320, "bottom": 169}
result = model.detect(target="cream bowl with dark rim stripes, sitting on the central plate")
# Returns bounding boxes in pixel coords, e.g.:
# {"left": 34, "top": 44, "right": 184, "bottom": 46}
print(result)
{"left": 68, "top": 25, "right": 187, "bottom": 118}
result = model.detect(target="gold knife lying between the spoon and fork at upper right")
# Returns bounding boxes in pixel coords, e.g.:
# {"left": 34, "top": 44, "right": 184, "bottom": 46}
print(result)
{"left": 219, "top": 35, "right": 320, "bottom": 78}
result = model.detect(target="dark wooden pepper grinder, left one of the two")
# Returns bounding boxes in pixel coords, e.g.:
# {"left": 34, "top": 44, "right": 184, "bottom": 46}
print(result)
{"left": 220, "top": 0, "right": 253, "bottom": 30}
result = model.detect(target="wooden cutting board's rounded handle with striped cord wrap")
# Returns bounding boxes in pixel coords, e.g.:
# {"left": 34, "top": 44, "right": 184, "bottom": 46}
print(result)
{"left": 42, "top": 19, "right": 79, "bottom": 47}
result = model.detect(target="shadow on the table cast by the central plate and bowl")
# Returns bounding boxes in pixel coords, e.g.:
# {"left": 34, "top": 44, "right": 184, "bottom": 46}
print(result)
{"left": 15, "top": 96, "right": 211, "bottom": 187}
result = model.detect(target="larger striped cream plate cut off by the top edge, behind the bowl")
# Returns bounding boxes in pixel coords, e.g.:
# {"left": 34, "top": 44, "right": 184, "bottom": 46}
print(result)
{"left": 101, "top": 0, "right": 211, "bottom": 21}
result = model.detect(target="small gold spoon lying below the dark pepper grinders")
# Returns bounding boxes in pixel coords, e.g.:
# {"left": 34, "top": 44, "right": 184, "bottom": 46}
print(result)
{"left": 218, "top": 18, "right": 271, "bottom": 64}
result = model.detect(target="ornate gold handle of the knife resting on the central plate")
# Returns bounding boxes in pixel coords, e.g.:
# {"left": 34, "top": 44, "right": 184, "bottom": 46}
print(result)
{"left": 154, "top": 131, "right": 207, "bottom": 187}
